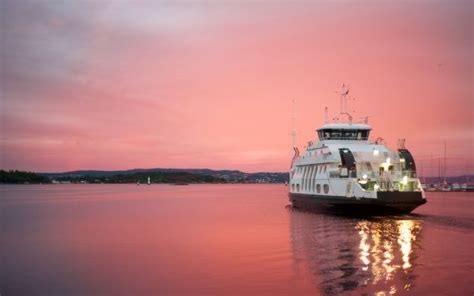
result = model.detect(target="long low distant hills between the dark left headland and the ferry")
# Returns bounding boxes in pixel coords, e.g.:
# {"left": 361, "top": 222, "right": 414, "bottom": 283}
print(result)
{"left": 41, "top": 168, "right": 289, "bottom": 183}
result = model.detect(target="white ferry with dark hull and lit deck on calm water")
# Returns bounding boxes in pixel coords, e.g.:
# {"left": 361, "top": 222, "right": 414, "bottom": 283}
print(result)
{"left": 288, "top": 89, "right": 426, "bottom": 215}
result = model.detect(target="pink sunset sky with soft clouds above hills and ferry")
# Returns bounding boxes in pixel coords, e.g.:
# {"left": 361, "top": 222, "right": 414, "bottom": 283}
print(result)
{"left": 0, "top": 1, "right": 474, "bottom": 175}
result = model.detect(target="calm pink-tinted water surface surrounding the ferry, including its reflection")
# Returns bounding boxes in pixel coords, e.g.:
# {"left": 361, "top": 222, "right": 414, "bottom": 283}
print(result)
{"left": 0, "top": 185, "right": 474, "bottom": 296}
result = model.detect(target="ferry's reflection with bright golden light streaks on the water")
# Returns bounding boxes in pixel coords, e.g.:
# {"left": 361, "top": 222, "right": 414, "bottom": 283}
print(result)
{"left": 290, "top": 211, "right": 423, "bottom": 295}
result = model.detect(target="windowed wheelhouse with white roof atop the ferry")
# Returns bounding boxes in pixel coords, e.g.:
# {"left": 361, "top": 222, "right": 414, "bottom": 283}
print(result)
{"left": 317, "top": 123, "right": 372, "bottom": 141}
